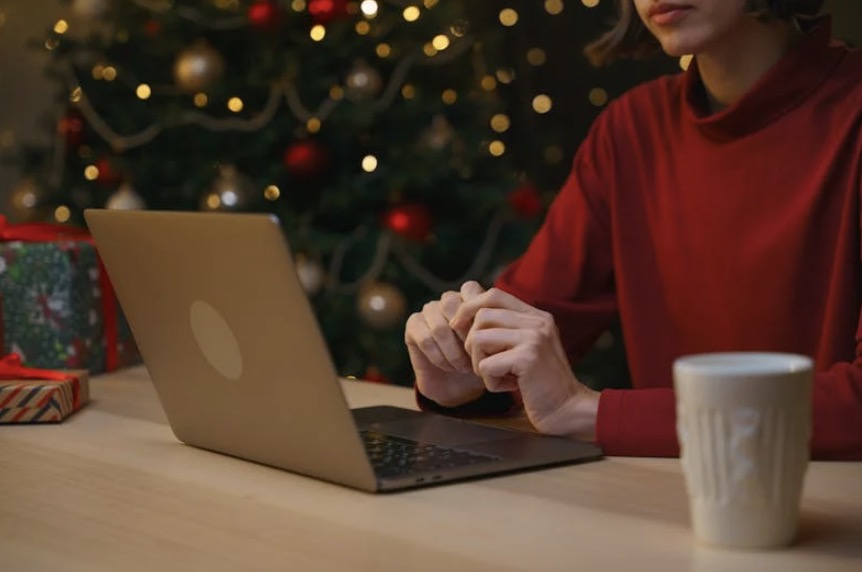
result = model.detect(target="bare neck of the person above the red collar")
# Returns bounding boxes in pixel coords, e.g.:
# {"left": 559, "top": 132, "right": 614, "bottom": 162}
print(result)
{"left": 697, "top": 19, "right": 802, "bottom": 113}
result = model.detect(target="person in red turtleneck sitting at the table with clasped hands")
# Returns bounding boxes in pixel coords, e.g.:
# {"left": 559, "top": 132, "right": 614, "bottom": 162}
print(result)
{"left": 405, "top": 0, "right": 862, "bottom": 460}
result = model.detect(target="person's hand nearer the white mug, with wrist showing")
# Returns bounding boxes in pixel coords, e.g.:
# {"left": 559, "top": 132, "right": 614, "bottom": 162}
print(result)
{"left": 450, "top": 288, "right": 599, "bottom": 440}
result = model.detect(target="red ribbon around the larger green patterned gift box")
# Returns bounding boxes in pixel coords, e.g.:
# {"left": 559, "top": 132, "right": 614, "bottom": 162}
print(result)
{"left": 0, "top": 215, "right": 120, "bottom": 371}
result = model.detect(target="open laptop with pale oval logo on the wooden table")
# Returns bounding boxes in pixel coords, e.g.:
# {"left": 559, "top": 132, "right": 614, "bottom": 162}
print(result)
{"left": 85, "top": 209, "right": 602, "bottom": 492}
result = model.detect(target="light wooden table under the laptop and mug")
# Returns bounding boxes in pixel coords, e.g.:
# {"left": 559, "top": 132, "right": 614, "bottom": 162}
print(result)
{"left": 0, "top": 368, "right": 862, "bottom": 572}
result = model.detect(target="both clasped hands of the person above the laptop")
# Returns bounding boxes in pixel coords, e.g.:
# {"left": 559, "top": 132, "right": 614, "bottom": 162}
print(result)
{"left": 404, "top": 281, "right": 599, "bottom": 441}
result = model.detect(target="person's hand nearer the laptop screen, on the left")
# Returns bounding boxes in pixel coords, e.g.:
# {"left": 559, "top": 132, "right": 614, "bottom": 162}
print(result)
{"left": 404, "top": 282, "right": 485, "bottom": 407}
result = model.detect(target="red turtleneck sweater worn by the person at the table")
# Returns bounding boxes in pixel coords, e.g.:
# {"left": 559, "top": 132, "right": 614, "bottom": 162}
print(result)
{"left": 422, "top": 21, "right": 862, "bottom": 459}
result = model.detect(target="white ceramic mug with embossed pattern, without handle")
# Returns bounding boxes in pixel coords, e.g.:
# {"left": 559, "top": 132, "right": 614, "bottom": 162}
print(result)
{"left": 673, "top": 352, "right": 813, "bottom": 548}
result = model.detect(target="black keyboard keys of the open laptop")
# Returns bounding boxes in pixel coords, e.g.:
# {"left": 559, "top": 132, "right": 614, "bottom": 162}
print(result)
{"left": 359, "top": 431, "right": 500, "bottom": 477}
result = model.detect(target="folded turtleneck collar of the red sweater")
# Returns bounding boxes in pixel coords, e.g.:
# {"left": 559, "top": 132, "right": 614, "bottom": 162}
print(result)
{"left": 684, "top": 16, "right": 843, "bottom": 140}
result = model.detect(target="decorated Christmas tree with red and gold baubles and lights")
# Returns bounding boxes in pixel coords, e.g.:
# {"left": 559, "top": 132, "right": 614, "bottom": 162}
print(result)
{"left": 8, "top": 0, "right": 544, "bottom": 384}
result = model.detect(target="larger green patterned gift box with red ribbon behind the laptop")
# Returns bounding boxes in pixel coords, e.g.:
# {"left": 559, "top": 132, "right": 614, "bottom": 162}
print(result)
{"left": 0, "top": 216, "right": 140, "bottom": 373}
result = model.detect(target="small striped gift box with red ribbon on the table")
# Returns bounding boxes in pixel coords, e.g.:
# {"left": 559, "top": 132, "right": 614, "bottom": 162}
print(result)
{"left": 0, "top": 354, "right": 90, "bottom": 423}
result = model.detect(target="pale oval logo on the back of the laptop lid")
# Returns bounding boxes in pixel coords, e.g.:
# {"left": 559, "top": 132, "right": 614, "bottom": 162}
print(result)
{"left": 189, "top": 300, "right": 242, "bottom": 380}
